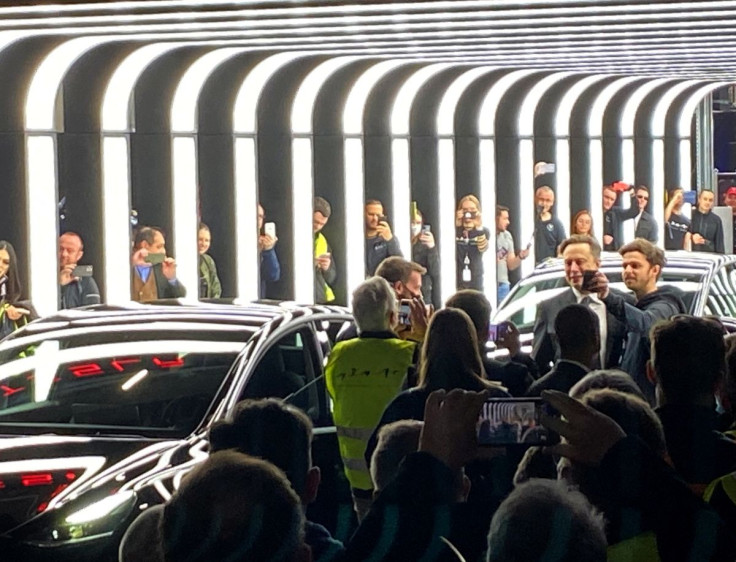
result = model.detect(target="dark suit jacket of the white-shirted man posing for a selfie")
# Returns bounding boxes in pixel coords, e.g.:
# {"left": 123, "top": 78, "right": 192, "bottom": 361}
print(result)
{"left": 532, "top": 288, "right": 634, "bottom": 373}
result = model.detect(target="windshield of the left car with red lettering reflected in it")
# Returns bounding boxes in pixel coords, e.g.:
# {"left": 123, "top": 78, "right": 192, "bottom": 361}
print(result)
{"left": 0, "top": 326, "right": 251, "bottom": 438}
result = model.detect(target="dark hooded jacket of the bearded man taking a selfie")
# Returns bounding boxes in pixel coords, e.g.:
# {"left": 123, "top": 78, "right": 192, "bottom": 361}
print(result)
{"left": 603, "top": 285, "right": 687, "bottom": 405}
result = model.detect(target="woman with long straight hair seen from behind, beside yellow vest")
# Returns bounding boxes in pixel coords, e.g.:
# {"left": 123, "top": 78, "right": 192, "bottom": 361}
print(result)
{"left": 366, "top": 308, "right": 509, "bottom": 464}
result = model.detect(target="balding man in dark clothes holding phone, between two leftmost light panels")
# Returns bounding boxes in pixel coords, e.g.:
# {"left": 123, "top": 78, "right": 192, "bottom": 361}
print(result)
{"left": 59, "top": 231, "right": 100, "bottom": 309}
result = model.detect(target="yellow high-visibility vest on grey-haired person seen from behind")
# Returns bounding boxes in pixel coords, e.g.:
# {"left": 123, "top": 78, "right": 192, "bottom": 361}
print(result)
{"left": 325, "top": 338, "right": 415, "bottom": 490}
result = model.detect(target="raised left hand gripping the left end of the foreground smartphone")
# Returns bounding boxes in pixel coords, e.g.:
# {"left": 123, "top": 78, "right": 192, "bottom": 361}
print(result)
{"left": 419, "top": 388, "right": 488, "bottom": 470}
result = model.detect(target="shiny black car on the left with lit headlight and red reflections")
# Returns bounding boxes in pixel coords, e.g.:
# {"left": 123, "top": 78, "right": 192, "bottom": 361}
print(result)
{"left": 0, "top": 304, "right": 351, "bottom": 560}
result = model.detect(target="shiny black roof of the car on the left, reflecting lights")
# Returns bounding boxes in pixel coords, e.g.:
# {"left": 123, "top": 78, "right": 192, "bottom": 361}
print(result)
{"left": 5, "top": 299, "right": 348, "bottom": 341}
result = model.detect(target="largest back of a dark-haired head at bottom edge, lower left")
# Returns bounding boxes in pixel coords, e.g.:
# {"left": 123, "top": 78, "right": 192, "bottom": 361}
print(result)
{"left": 161, "top": 451, "right": 304, "bottom": 562}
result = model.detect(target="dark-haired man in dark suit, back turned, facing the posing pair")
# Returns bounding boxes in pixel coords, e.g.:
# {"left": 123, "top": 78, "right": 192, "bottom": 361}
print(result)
{"left": 527, "top": 304, "right": 601, "bottom": 396}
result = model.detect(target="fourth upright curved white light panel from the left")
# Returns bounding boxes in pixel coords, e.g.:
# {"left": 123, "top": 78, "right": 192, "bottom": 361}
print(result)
{"left": 171, "top": 47, "right": 245, "bottom": 300}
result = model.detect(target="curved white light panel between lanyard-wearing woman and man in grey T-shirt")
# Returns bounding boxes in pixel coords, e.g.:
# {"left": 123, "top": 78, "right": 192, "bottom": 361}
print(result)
{"left": 478, "top": 70, "right": 538, "bottom": 304}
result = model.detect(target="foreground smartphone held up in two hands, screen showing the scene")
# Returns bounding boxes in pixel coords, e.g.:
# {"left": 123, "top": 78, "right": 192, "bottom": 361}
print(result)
{"left": 476, "top": 398, "right": 559, "bottom": 447}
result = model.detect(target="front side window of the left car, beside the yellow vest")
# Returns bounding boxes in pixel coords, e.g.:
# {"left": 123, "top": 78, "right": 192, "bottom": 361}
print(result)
{"left": 241, "top": 327, "right": 322, "bottom": 423}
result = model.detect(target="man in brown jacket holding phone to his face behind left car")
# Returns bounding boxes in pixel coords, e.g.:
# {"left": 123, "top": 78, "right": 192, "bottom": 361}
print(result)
{"left": 130, "top": 226, "right": 187, "bottom": 302}
